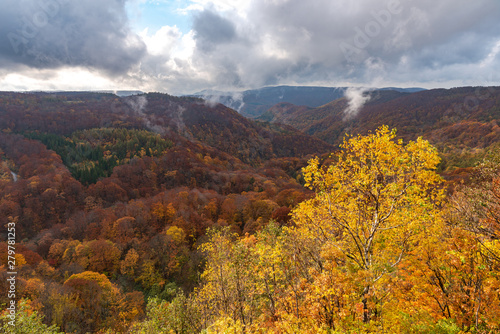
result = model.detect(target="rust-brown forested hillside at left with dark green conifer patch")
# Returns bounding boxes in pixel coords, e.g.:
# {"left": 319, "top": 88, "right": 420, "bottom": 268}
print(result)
{"left": 0, "top": 93, "right": 326, "bottom": 333}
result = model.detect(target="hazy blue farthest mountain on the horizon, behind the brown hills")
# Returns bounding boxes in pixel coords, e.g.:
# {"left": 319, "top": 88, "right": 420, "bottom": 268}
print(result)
{"left": 193, "top": 86, "right": 424, "bottom": 118}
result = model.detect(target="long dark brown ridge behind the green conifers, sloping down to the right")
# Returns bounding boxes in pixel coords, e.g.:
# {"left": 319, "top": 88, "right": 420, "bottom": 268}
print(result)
{"left": 0, "top": 92, "right": 333, "bottom": 165}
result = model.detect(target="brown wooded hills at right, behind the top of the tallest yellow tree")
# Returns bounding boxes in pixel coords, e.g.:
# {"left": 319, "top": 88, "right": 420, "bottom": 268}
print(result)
{"left": 260, "top": 87, "right": 500, "bottom": 170}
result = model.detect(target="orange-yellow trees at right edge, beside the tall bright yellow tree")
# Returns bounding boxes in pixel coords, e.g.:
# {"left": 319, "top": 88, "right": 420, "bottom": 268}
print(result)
{"left": 425, "top": 152, "right": 500, "bottom": 332}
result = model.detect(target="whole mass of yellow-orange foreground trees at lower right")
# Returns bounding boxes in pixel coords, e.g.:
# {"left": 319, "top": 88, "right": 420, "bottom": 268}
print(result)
{"left": 167, "top": 126, "right": 500, "bottom": 334}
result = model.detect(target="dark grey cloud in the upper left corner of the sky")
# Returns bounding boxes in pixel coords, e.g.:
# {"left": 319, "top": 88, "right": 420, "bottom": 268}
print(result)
{"left": 0, "top": 0, "right": 146, "bottom": 75}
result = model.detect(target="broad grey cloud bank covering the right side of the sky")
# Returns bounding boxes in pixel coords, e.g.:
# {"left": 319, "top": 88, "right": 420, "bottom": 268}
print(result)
{"left": 187, "top": 0, "right": 500, "bottom": 91}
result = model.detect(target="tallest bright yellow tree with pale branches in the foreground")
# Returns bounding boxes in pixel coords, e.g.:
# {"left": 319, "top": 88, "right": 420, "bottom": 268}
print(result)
{"left": 293, "top": 126, "right": 442, "bottom": 326}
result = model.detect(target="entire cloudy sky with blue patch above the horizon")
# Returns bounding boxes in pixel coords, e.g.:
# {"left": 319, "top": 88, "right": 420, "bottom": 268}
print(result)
{"left": 0, "top": 0, "right": 500, "bottom": 95}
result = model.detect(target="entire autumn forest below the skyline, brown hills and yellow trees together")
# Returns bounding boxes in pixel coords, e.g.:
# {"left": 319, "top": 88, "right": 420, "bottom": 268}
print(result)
{"left": 0, "top": 87, "right": 500, "bottom": 334}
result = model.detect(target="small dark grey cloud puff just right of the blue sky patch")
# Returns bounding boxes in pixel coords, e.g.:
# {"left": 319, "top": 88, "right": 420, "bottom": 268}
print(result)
{"left": 193, "top": 10, "right": 236, "bottom": 51}
